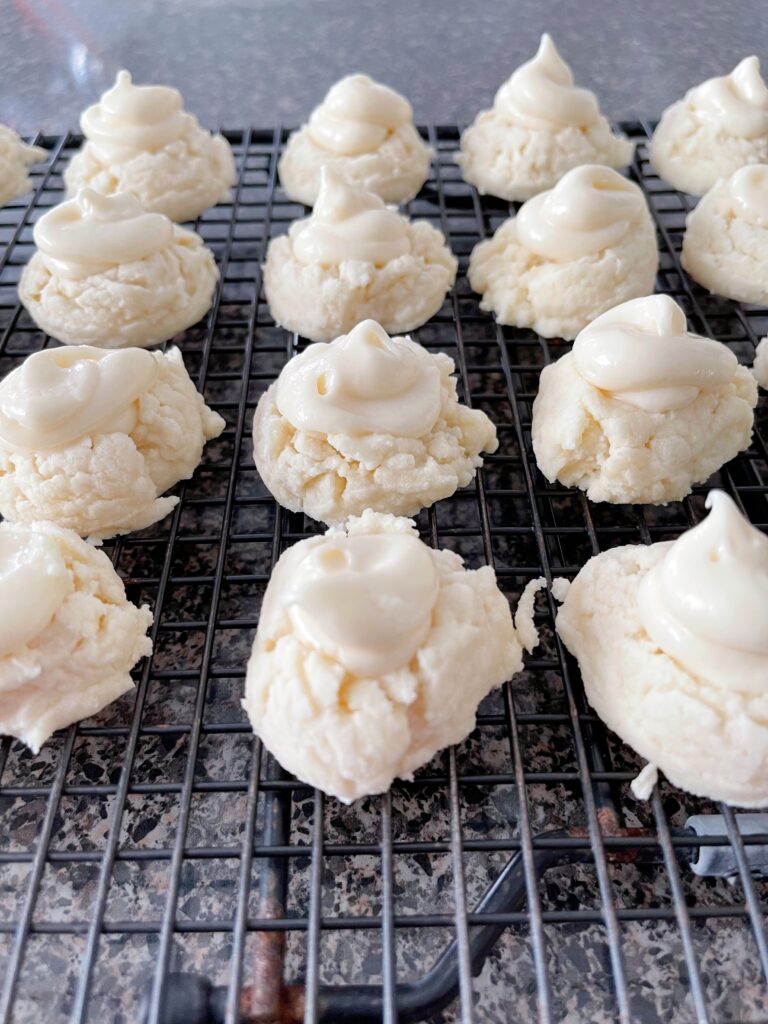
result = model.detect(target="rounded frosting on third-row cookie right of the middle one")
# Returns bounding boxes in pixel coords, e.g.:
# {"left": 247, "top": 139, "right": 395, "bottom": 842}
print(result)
{"left": 515, "top": 164, "right": 647, "bottom": 262}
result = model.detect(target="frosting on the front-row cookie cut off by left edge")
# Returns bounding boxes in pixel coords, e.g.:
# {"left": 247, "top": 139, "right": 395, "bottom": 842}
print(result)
{"left": 0, "top": 524, "right": 71, "bottom": 654}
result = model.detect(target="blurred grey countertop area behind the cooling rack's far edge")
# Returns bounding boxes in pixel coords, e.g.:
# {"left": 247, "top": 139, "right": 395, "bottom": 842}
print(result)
{"left": 0, "top": 0, "right": 768, "bottom": 133}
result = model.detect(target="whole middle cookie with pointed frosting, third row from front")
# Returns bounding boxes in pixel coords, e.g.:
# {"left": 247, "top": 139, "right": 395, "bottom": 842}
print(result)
{"left": 264, "top": 167, "right": 457, "bottom": 341}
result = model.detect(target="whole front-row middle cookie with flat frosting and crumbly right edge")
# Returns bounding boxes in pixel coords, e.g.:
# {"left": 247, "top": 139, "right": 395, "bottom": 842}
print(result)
{"left": 243, "top": 511, "right": 542, "bottom": 803}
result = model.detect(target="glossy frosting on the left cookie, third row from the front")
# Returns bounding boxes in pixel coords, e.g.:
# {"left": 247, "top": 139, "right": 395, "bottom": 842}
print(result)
{"left": 34, "top": 188, "right": 174, "bottom": 278}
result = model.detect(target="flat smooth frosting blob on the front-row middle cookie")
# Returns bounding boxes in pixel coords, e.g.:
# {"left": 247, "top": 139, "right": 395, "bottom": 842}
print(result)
{"left": 274, "top": 534, "right": 438, "bottom": 677}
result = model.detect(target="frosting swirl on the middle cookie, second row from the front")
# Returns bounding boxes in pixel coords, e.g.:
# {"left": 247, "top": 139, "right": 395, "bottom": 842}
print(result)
{"left": 275, "top": 321, "right": 441, "bottom": 437}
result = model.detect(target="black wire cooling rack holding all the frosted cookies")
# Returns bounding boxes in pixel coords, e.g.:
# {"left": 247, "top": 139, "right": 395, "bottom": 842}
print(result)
{"left": 0, "top": 124, "right": 768, "bottom": 1024}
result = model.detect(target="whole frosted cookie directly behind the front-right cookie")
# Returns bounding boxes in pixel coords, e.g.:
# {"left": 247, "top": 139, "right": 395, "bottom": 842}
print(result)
{"left": 531, "top": 295, "right": 757, "bottom": 505}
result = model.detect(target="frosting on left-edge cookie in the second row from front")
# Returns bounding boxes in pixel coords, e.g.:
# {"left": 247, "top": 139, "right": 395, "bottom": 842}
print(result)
{"left": 0, "top": 345, "right": 158, "bottom": 452}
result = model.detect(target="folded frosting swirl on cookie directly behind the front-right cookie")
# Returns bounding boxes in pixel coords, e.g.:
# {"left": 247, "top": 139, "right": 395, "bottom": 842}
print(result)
{"left": 572, "top": 295, "right": 738, "bottom": 413}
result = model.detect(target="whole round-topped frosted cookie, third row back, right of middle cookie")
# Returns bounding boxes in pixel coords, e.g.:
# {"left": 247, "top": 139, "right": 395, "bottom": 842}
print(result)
{"left": 469, "top": 166, "right": 658, "bottom": 339}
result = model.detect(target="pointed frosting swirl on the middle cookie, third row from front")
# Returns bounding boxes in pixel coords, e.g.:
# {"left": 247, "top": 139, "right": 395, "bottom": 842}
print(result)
{"left": 290, "top": 166, "right": 411, "bottom": 266}
